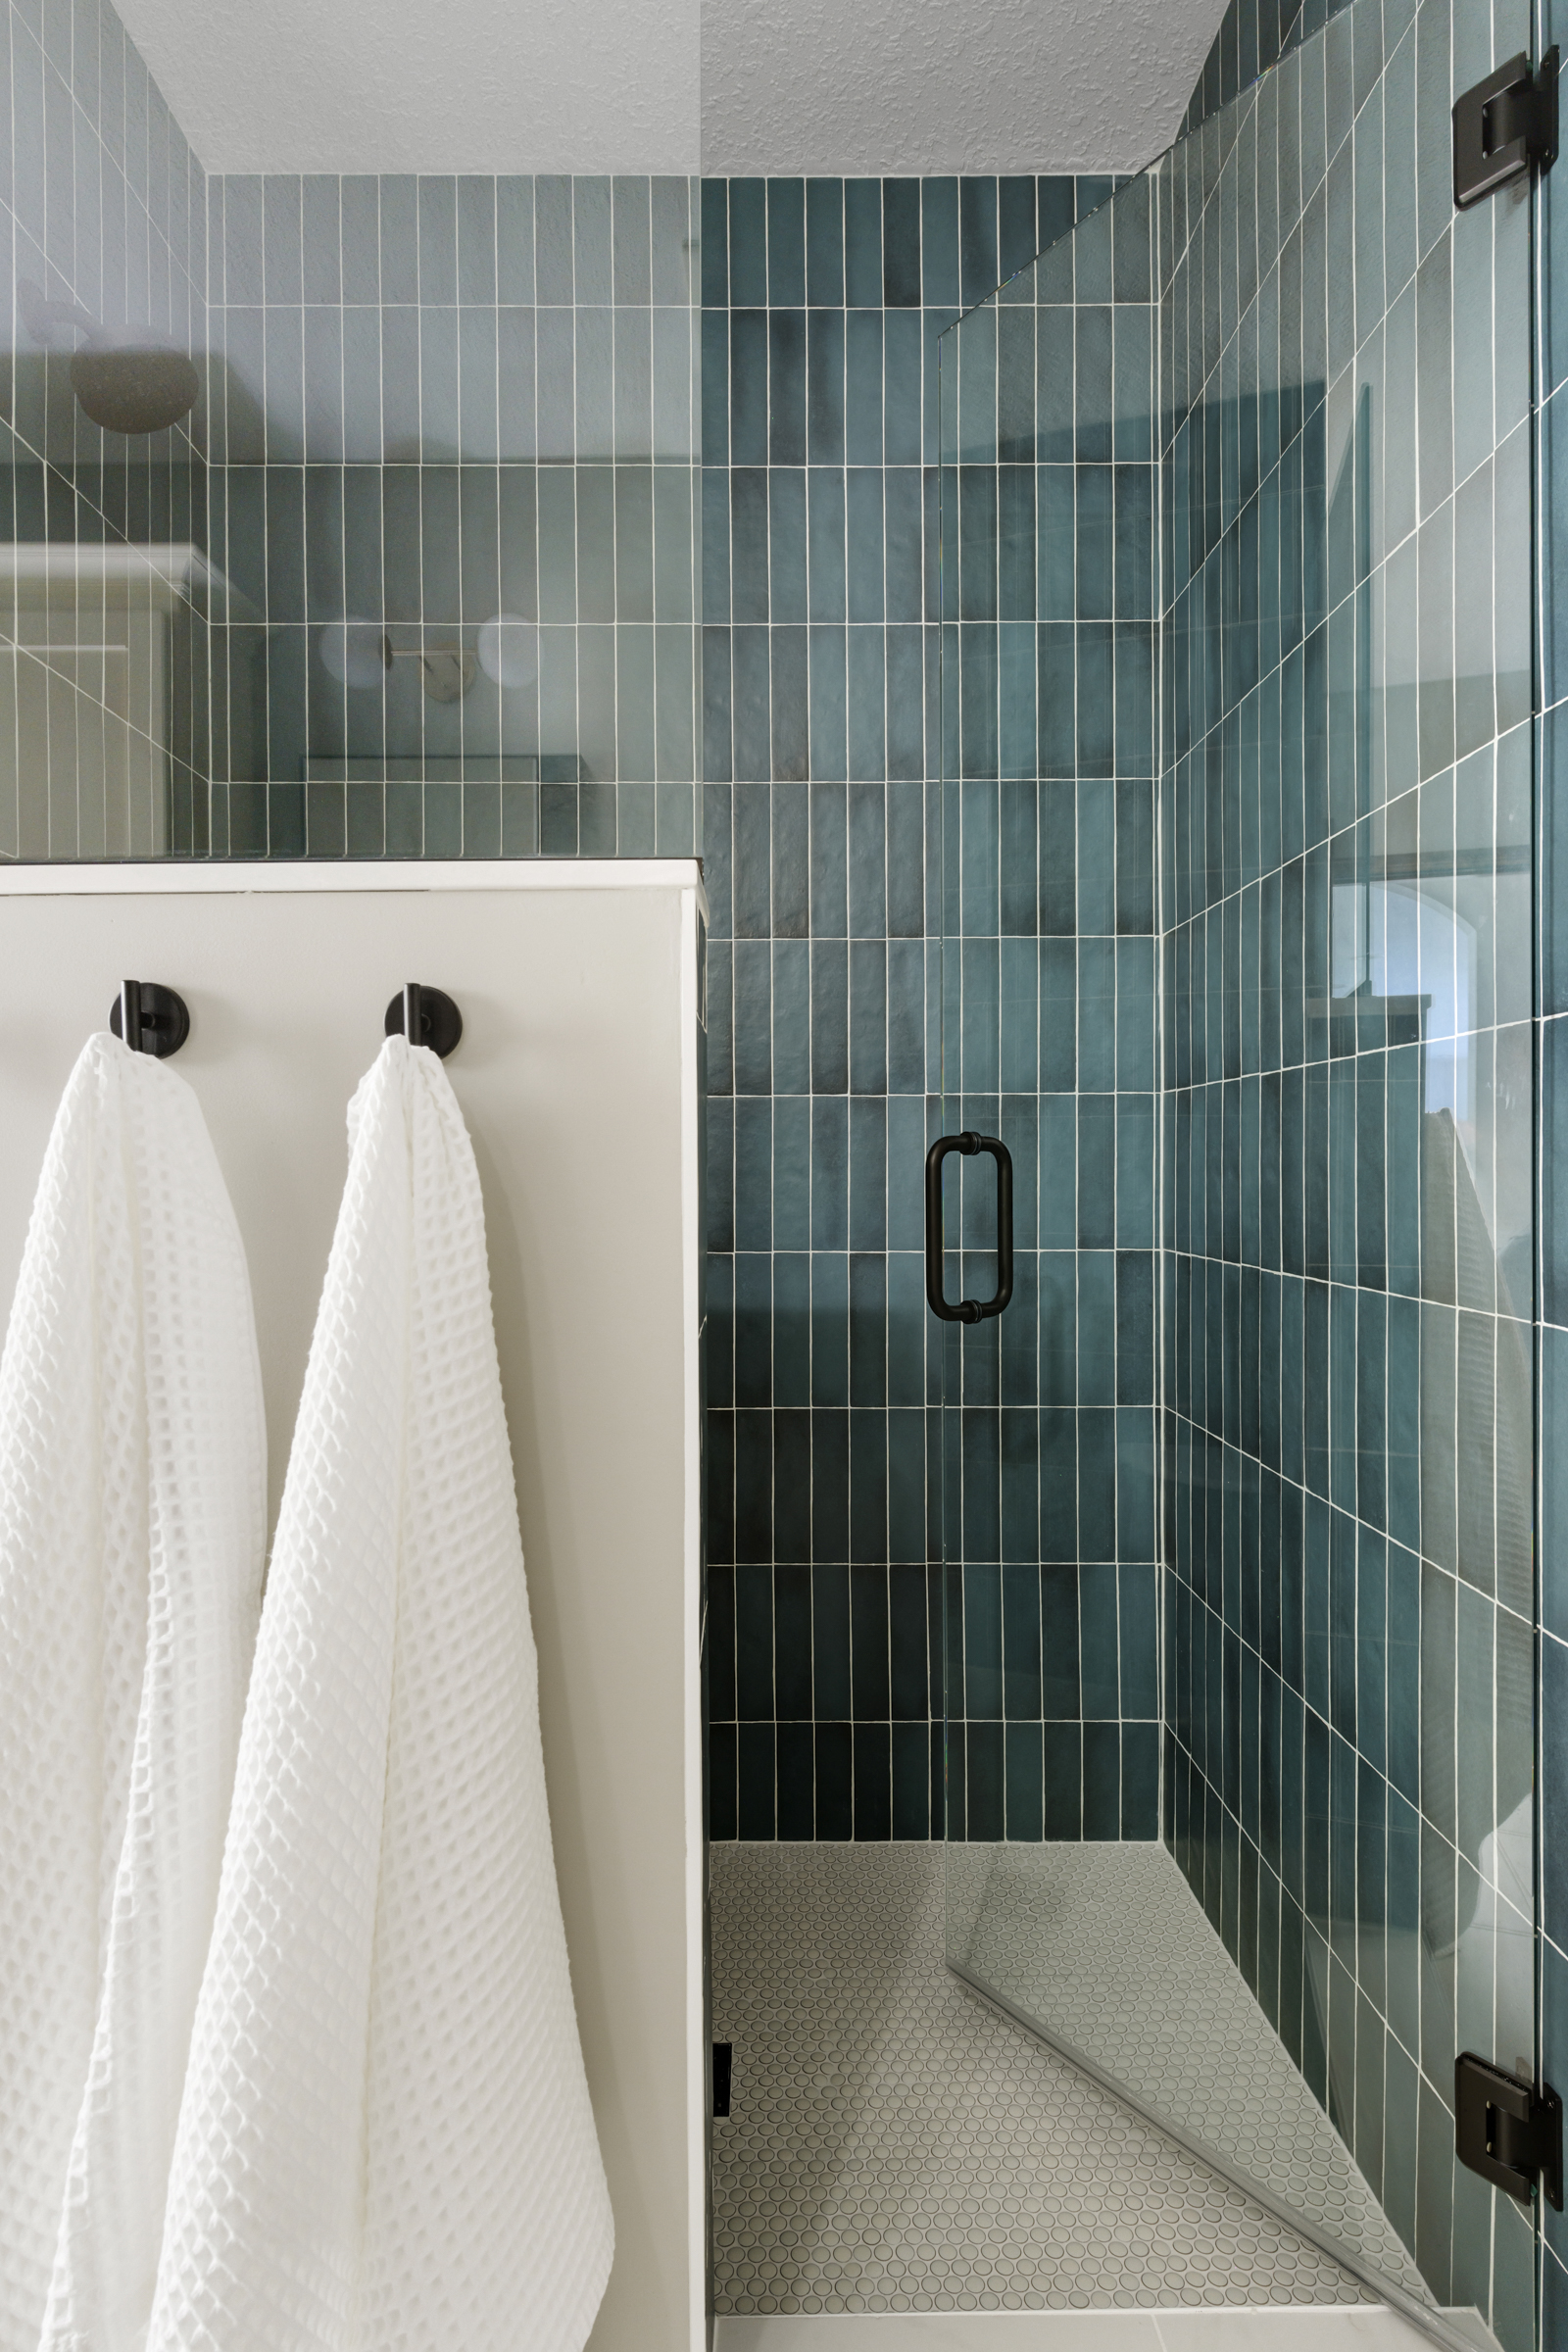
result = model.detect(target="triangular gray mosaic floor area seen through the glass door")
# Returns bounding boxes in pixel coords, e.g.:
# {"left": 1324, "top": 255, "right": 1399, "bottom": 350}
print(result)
{"left": 948, "top": 1844, "right": 1429, "bottom": 2303}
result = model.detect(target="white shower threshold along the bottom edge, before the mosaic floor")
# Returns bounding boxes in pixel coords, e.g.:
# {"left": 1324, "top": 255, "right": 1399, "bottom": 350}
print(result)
{"left": 712, "top": 2303, "right": 1495, "bottom": 2352}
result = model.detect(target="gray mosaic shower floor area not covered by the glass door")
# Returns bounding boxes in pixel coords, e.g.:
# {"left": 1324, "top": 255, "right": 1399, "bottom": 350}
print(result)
{"left": 710, "top": 1844, "right": 1371, "bottom": 2312}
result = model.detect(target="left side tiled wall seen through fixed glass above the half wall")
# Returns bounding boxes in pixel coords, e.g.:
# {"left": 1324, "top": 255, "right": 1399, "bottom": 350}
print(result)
{"left": 0, "top": 0, "right": 209, "bottom": 858}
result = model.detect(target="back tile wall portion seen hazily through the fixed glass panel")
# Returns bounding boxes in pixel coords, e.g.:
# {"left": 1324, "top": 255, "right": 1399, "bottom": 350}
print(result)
{"left": 207, "top": 176, "right": 698, "bottom": 857}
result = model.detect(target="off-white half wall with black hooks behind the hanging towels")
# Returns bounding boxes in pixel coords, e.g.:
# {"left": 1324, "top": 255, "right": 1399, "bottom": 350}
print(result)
{"left": 0, "top": 858, "right": 706, "bottom": 2352}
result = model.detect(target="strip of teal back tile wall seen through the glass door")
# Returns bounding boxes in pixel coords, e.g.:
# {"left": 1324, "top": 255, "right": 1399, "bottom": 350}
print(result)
{"left": 941, "top": 176, "right": 1159, "bottom": 1839}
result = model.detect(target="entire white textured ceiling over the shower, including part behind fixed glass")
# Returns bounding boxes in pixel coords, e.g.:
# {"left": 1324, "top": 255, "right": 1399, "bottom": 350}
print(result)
{"left": 120, "top": 0, "right": 1222, "bottom": 174}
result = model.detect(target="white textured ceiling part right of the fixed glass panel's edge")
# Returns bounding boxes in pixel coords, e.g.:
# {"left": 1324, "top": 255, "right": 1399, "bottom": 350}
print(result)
{"left": 703, "top": 0, "right": 1225, "bottom": 174}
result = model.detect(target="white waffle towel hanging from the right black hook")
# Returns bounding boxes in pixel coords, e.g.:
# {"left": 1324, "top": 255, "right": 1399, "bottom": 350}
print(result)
{"left": 148, "top": 1037, "right": 613, "bottom": 2352}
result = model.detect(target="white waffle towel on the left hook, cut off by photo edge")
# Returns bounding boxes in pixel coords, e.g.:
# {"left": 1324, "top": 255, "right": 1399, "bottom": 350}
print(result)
{"left": 0, "top": 1035, "right": 266, "bottom": 2352}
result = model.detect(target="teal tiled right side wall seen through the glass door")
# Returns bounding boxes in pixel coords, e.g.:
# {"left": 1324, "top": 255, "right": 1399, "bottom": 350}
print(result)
{"left": 1159, "top": 0, "right": 1533, "bottom": 2345}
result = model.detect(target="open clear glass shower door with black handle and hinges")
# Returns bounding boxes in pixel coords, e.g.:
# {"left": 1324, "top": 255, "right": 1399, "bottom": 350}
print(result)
{"left": 941, "top": 0, "right": 1540, "bottom": 2352}
